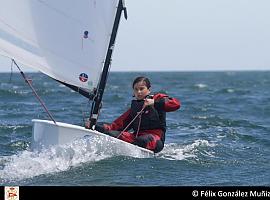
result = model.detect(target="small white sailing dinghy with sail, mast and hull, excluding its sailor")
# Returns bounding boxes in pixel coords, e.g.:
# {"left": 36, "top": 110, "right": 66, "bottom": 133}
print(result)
{"left": 0, "top": 0, "right": 154, "bottom": 156}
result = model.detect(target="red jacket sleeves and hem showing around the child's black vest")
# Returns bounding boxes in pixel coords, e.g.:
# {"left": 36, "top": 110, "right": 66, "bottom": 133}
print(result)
{"left": 104, "top": 93, "right": 181, "bottom": 136}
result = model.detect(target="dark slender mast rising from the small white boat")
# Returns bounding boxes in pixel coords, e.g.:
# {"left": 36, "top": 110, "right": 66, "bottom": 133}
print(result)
{"left": 90, "top": 0, "right": 127, "bottom": 129}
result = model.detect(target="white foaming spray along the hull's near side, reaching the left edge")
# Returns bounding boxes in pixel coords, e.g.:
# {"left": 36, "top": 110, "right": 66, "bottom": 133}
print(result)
{"left": 0, "top": 137, "right": 150, "bottom": 184}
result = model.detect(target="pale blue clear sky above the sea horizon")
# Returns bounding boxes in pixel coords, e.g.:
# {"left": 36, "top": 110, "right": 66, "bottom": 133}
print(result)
{"left": 0, "top": 0, "right": 270, "bottom": 71}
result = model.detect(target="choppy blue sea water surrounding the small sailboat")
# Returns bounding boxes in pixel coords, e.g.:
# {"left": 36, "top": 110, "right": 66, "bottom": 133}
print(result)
{"left": 0, "top": 71, "right": 270, "bottom": 186}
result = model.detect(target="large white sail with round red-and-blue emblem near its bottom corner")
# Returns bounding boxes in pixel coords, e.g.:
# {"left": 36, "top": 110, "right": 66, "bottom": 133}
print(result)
{"left": 0, "top": 0, "right": 119, "bottom": 90}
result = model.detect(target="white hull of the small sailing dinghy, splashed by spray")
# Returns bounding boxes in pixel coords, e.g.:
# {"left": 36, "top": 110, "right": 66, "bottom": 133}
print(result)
{"left": 31, "top": 119, "right": 154, "bottom": 157}
